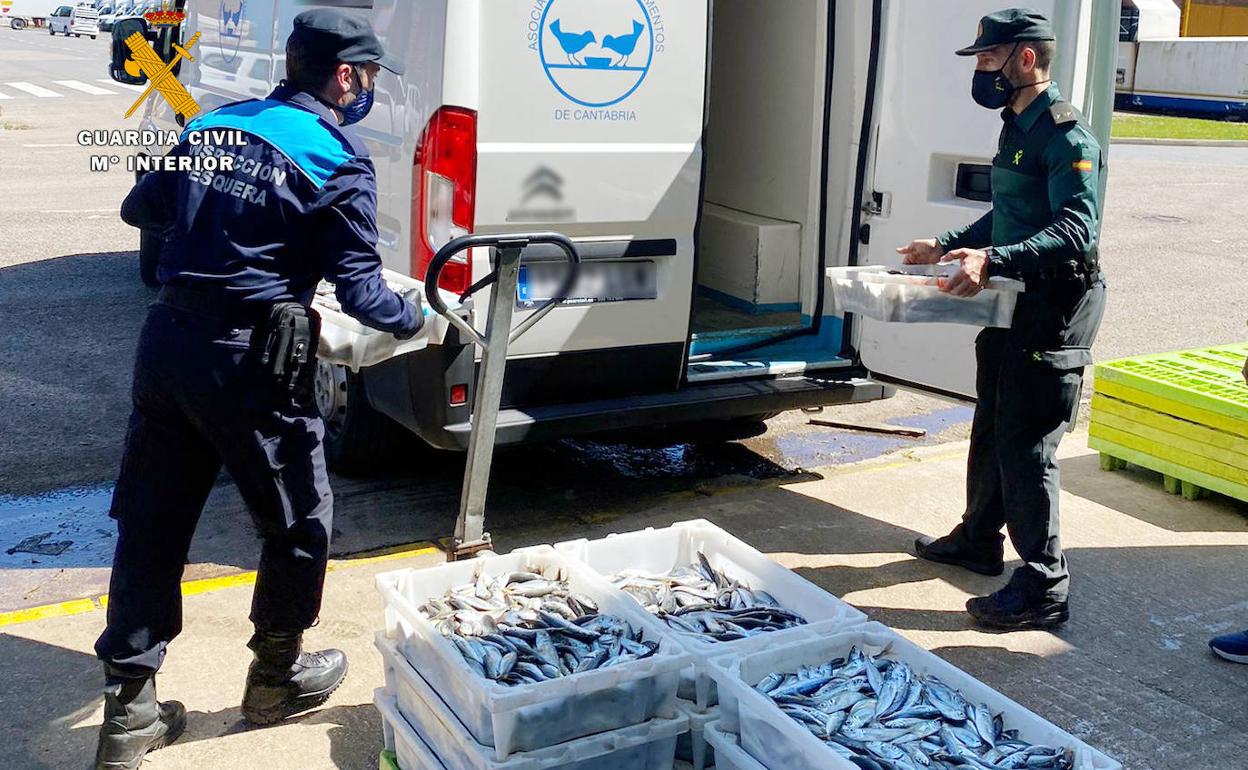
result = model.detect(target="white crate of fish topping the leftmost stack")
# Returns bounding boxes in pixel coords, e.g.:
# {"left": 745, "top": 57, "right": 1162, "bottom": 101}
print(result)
{"left": 377, "top": 548, "right": 689, "bottom": 760}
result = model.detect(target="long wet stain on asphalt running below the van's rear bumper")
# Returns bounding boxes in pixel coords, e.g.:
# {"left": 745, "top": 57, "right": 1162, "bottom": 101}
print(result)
{"left": 0, "top": 407, "right": 972, "bottom": 569}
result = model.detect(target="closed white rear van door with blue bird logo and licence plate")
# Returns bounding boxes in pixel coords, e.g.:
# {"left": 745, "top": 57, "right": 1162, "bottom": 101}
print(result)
{"left": 471, "top": 0, "right": 708, "bottom": 374}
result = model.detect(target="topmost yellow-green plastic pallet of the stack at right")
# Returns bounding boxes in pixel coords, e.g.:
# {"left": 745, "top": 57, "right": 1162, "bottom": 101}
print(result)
{"left": 1096, "top": 342, "right": 1248, "bottom": 422}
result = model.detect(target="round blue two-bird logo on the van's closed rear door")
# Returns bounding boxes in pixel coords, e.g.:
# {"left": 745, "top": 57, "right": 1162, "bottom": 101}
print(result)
{"left": 537, "top": 0, "right": 655, "bottom": 107}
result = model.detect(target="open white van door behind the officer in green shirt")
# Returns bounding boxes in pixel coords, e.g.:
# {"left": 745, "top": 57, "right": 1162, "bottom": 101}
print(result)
{"left": 852, "top": 0, "right": 1118, "bottom": 399}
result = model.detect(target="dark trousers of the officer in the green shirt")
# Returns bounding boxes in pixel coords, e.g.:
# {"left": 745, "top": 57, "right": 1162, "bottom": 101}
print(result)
{"left": 953, "top": 280, "right": 1104, "bottom": 600}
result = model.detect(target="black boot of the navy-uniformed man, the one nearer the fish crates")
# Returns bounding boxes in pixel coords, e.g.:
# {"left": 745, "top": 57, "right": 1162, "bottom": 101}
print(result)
{"left": 242, "top": 631, "right": 347, "bottom": 725}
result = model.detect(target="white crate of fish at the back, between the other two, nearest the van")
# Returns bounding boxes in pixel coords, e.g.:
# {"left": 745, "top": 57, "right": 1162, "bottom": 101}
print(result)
{"left": 555, "top": 519, "right": 866, "bottom": 708}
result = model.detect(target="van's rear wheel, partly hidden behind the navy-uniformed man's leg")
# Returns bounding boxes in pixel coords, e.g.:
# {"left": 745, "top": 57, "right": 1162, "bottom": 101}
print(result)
{"left": 316, "top": 361, "right": 409, "bottom": 477}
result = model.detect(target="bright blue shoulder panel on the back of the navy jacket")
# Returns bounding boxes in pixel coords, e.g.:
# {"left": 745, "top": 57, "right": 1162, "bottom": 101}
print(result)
{"left": 182, "top": 99, "right": 356, "bottom": 190}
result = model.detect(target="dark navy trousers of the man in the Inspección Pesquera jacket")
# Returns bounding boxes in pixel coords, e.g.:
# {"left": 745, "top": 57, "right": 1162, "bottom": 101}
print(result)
{"left": 95, "top": 305, "right": 333, "bottom": 676}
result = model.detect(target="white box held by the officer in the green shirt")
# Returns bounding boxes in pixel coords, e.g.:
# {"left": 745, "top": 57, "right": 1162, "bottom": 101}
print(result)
{"left": 827, "top": 265, "right": 1026, "bottom": 328}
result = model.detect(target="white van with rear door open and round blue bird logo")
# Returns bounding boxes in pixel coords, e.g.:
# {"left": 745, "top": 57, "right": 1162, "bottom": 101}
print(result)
{"left": 129, "top": 0, "right": 1119, "bottom": 467}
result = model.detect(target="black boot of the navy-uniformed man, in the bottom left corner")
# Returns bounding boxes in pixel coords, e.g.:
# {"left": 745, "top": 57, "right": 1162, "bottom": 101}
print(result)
{"left": 95, "top": 676, "right": 186, "bottom": 770}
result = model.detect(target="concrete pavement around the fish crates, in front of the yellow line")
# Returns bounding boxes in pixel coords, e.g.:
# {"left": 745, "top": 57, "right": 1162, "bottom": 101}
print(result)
{"left": 0, "top": 433, "right": 1248, "bottom": 770}
